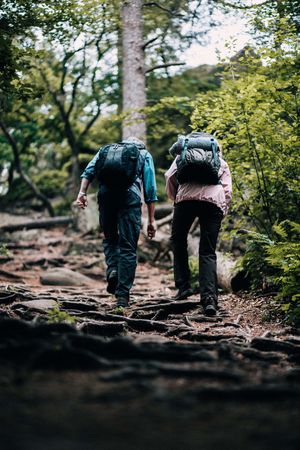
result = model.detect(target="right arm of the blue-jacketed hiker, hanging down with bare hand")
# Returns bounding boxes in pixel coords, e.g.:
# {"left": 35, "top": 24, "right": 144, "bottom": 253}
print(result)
{"left": 143, "top": 152, "right": 157, "bottom": 239}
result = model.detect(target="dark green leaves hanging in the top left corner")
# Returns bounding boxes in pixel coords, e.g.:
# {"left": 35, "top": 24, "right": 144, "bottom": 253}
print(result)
{"left": 0, "top": 0, "right": 84, "bottom": 102}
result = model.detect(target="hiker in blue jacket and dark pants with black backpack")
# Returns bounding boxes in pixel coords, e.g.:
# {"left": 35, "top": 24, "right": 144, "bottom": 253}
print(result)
{"left": 76, "top": 137, "right": 157, "bottom": 307}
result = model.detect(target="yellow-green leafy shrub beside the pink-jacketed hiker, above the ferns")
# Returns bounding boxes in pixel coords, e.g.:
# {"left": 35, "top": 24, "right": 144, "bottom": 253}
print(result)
{"left": 192, "top": 23, "right": 300, "bottom": 237}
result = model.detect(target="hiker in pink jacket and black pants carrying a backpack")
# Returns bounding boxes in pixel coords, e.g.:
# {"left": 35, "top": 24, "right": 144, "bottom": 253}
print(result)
{"left": 165, "top": 133, "right": 232, "bottom": 316}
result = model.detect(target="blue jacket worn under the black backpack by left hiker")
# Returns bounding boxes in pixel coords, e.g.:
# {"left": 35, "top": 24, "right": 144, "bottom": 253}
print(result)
{"left": 81, "top": 141, "right": 157, "bottom": 203}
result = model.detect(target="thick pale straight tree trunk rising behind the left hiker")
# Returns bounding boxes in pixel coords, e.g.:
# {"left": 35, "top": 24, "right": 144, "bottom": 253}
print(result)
{"left": 122, "top": 0, "right": 146, "bottom": 141}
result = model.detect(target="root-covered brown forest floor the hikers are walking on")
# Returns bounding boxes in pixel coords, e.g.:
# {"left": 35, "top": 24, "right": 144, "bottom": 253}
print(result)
{"left": 0, "top": 222, "right": 300, "bottom": 450}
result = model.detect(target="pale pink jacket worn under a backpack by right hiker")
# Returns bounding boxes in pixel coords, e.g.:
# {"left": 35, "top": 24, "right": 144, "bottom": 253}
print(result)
{"left": 165, "top": 156, "right": 232, "bottom": 214}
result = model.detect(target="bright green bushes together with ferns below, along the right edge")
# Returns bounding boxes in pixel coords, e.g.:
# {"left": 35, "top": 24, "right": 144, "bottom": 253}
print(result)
{"left": 188, "top": 13, "right": 300, "bottom": 319}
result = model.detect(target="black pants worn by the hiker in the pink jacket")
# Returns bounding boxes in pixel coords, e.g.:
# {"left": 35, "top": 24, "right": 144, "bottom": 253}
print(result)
{"left": 171, "top": 200, "right": 223, "bottom": 301}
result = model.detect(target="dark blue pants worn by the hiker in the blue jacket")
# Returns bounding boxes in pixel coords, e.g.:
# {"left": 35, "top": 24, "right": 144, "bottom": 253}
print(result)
{"left": 99, "top": 193, "right": 141, "bottom": 298}
